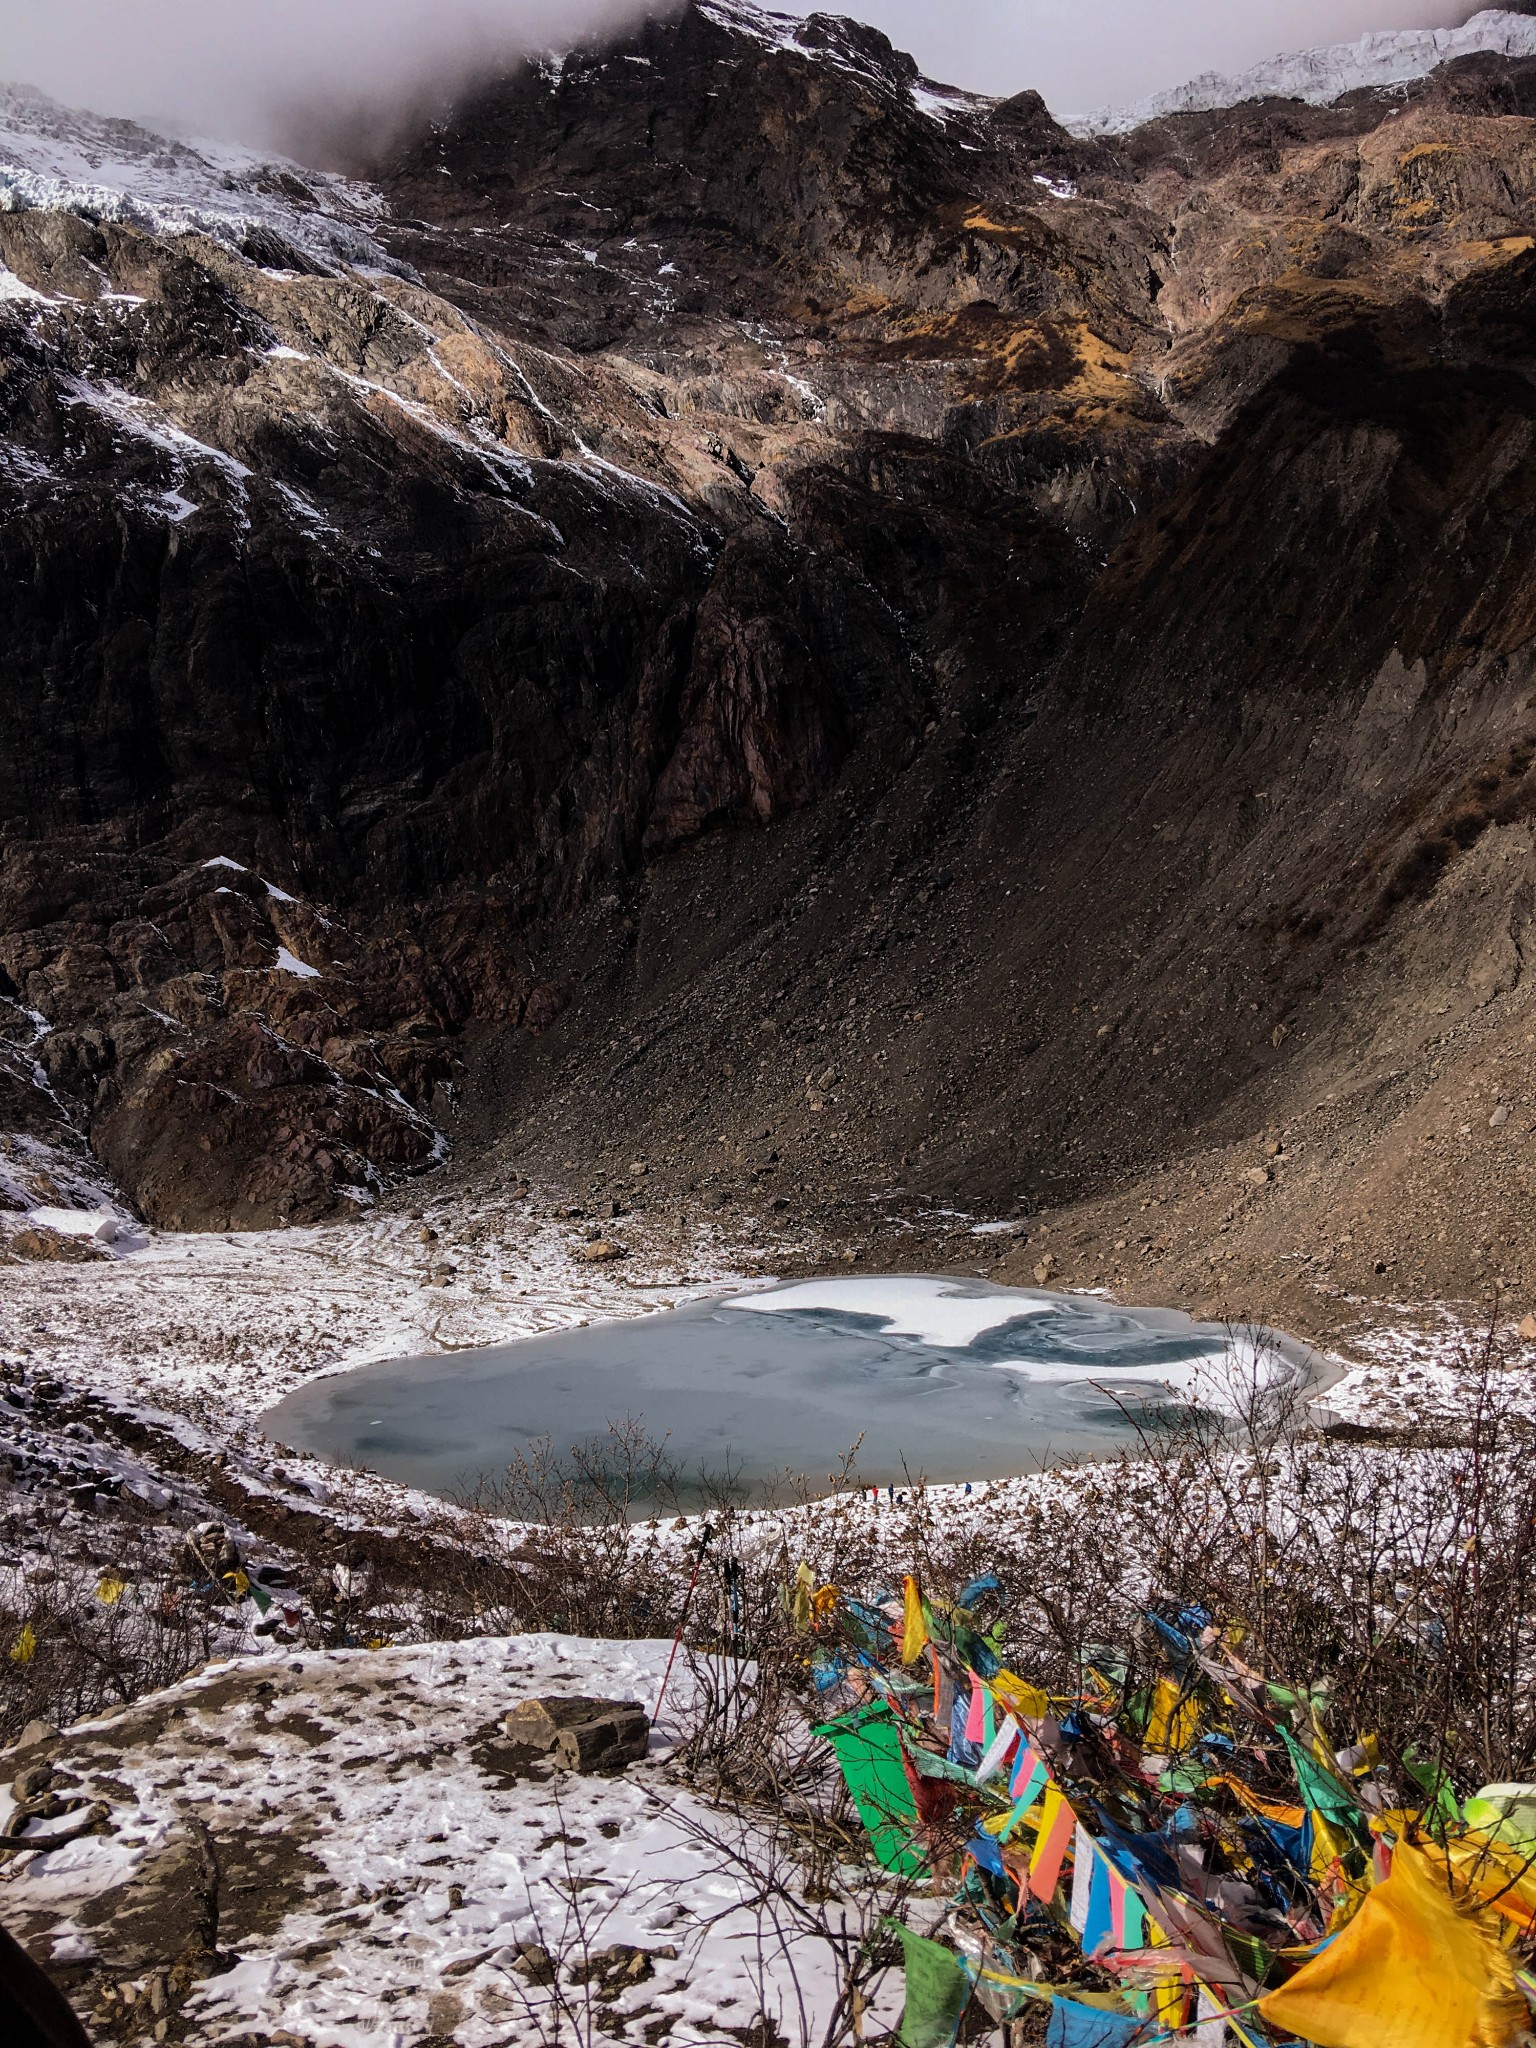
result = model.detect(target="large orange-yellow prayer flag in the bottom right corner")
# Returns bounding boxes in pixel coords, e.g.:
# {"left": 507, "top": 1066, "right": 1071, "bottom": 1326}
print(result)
{"left": 1260, "top": 1843, "right": 1528, "bottom": 2048}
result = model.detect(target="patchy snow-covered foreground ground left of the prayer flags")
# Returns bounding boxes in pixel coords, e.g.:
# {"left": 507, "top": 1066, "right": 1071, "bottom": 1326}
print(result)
{"left": 0, "top": 1634, "right": 899, "bottom": 2048}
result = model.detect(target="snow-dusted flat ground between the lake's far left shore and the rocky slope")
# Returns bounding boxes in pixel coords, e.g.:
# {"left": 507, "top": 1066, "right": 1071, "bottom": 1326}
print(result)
{"left": 0, "top": 1198, "right": 770, "bottom": 1430}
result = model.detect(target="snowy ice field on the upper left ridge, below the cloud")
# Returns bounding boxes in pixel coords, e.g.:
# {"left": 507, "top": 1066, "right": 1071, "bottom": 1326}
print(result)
{"left": 0, "top": 86, "right": 397, "bottom": 270}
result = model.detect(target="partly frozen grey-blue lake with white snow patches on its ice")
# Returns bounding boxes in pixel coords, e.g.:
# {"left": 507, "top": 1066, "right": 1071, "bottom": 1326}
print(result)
{"left": 262, "top": 1276, "right": 1309, "bottom": 1501}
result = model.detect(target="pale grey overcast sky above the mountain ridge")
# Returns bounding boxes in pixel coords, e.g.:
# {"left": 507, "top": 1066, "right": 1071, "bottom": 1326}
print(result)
{"left": 0, "top": 0, "right": 1468, "bottom": 141}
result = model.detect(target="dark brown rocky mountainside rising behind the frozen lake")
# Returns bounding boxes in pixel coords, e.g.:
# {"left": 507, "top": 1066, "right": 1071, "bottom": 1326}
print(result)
{"left": 0, "top": 0, "right": 1536, "bottom": 1327}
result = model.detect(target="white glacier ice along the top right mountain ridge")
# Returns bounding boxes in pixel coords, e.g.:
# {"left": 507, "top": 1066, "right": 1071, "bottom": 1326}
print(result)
{"left": 1065, "top": 8, "right": 1536, "bottom": 135}
